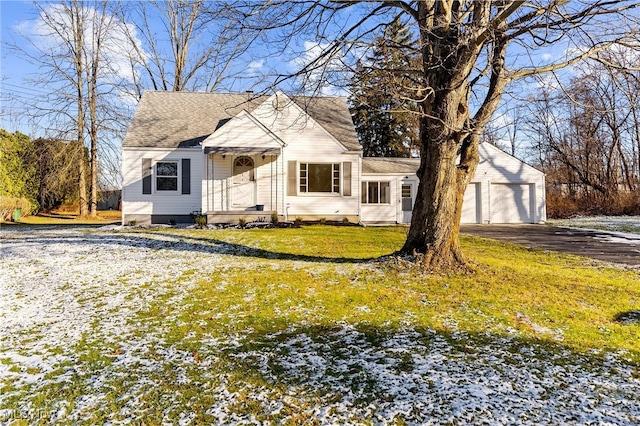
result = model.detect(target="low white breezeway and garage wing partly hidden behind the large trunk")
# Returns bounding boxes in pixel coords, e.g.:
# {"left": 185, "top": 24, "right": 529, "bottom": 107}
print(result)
{"left": 360, "top": 143, "right": 547, "bottom": 223}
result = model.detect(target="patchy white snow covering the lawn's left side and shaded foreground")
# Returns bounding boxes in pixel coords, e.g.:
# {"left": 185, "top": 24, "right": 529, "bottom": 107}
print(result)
{"left": 0, "top": 228, "right": 640, "bottom": 425}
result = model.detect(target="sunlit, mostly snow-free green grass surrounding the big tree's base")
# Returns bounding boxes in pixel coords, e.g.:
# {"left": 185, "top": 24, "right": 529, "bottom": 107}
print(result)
{"left": 146, "top": 226, "right": 640, "bottom": 356}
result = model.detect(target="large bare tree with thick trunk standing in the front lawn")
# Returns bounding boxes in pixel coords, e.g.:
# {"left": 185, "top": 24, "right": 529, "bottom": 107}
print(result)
{"left": 234, "top": 0, "right": 640, "bottom": 268}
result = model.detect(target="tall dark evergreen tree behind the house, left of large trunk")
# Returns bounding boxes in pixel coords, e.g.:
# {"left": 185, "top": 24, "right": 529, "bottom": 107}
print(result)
{"left": 349, "top": 18, "right": 419, "bottom": 157}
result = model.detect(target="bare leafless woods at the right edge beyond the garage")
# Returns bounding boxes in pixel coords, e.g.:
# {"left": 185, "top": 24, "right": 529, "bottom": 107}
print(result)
{"left": 523, "top": 57, "right": 640, "bottom": 217}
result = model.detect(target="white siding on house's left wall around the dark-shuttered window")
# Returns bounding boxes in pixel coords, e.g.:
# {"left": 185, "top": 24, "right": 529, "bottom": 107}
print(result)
{"left": 122, "top": 148, "right": 203, "bottom": 220}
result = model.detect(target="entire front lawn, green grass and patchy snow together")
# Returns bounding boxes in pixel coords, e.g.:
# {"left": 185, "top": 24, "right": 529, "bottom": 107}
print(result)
{"left": 0, "top": 226, "right": 640, "bottom": 424}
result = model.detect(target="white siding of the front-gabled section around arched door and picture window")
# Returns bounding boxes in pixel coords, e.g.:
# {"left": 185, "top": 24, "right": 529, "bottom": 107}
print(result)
{"left": 202, "top": 96, "right": 361, "bottom": 219}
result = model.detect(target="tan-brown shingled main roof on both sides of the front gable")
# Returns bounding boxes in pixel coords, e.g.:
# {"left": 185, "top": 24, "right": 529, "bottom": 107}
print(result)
{"left": 122, "top": 91, "right": 361, "bottom": 151}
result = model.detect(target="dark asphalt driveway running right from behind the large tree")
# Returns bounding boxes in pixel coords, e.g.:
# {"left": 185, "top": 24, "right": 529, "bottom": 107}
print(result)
{"left": 460, "top": 225, "right": 640, "bottom": 267}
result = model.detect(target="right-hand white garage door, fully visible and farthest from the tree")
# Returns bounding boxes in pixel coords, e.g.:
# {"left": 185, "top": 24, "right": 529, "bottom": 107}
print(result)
{"left": 491, "top": 183, "right": 533, "bottom": 223}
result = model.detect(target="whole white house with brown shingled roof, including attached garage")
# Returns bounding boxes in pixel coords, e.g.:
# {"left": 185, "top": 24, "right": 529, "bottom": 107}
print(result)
{"left": 122, "top": 92, "right": 545, "bottom": 224}
